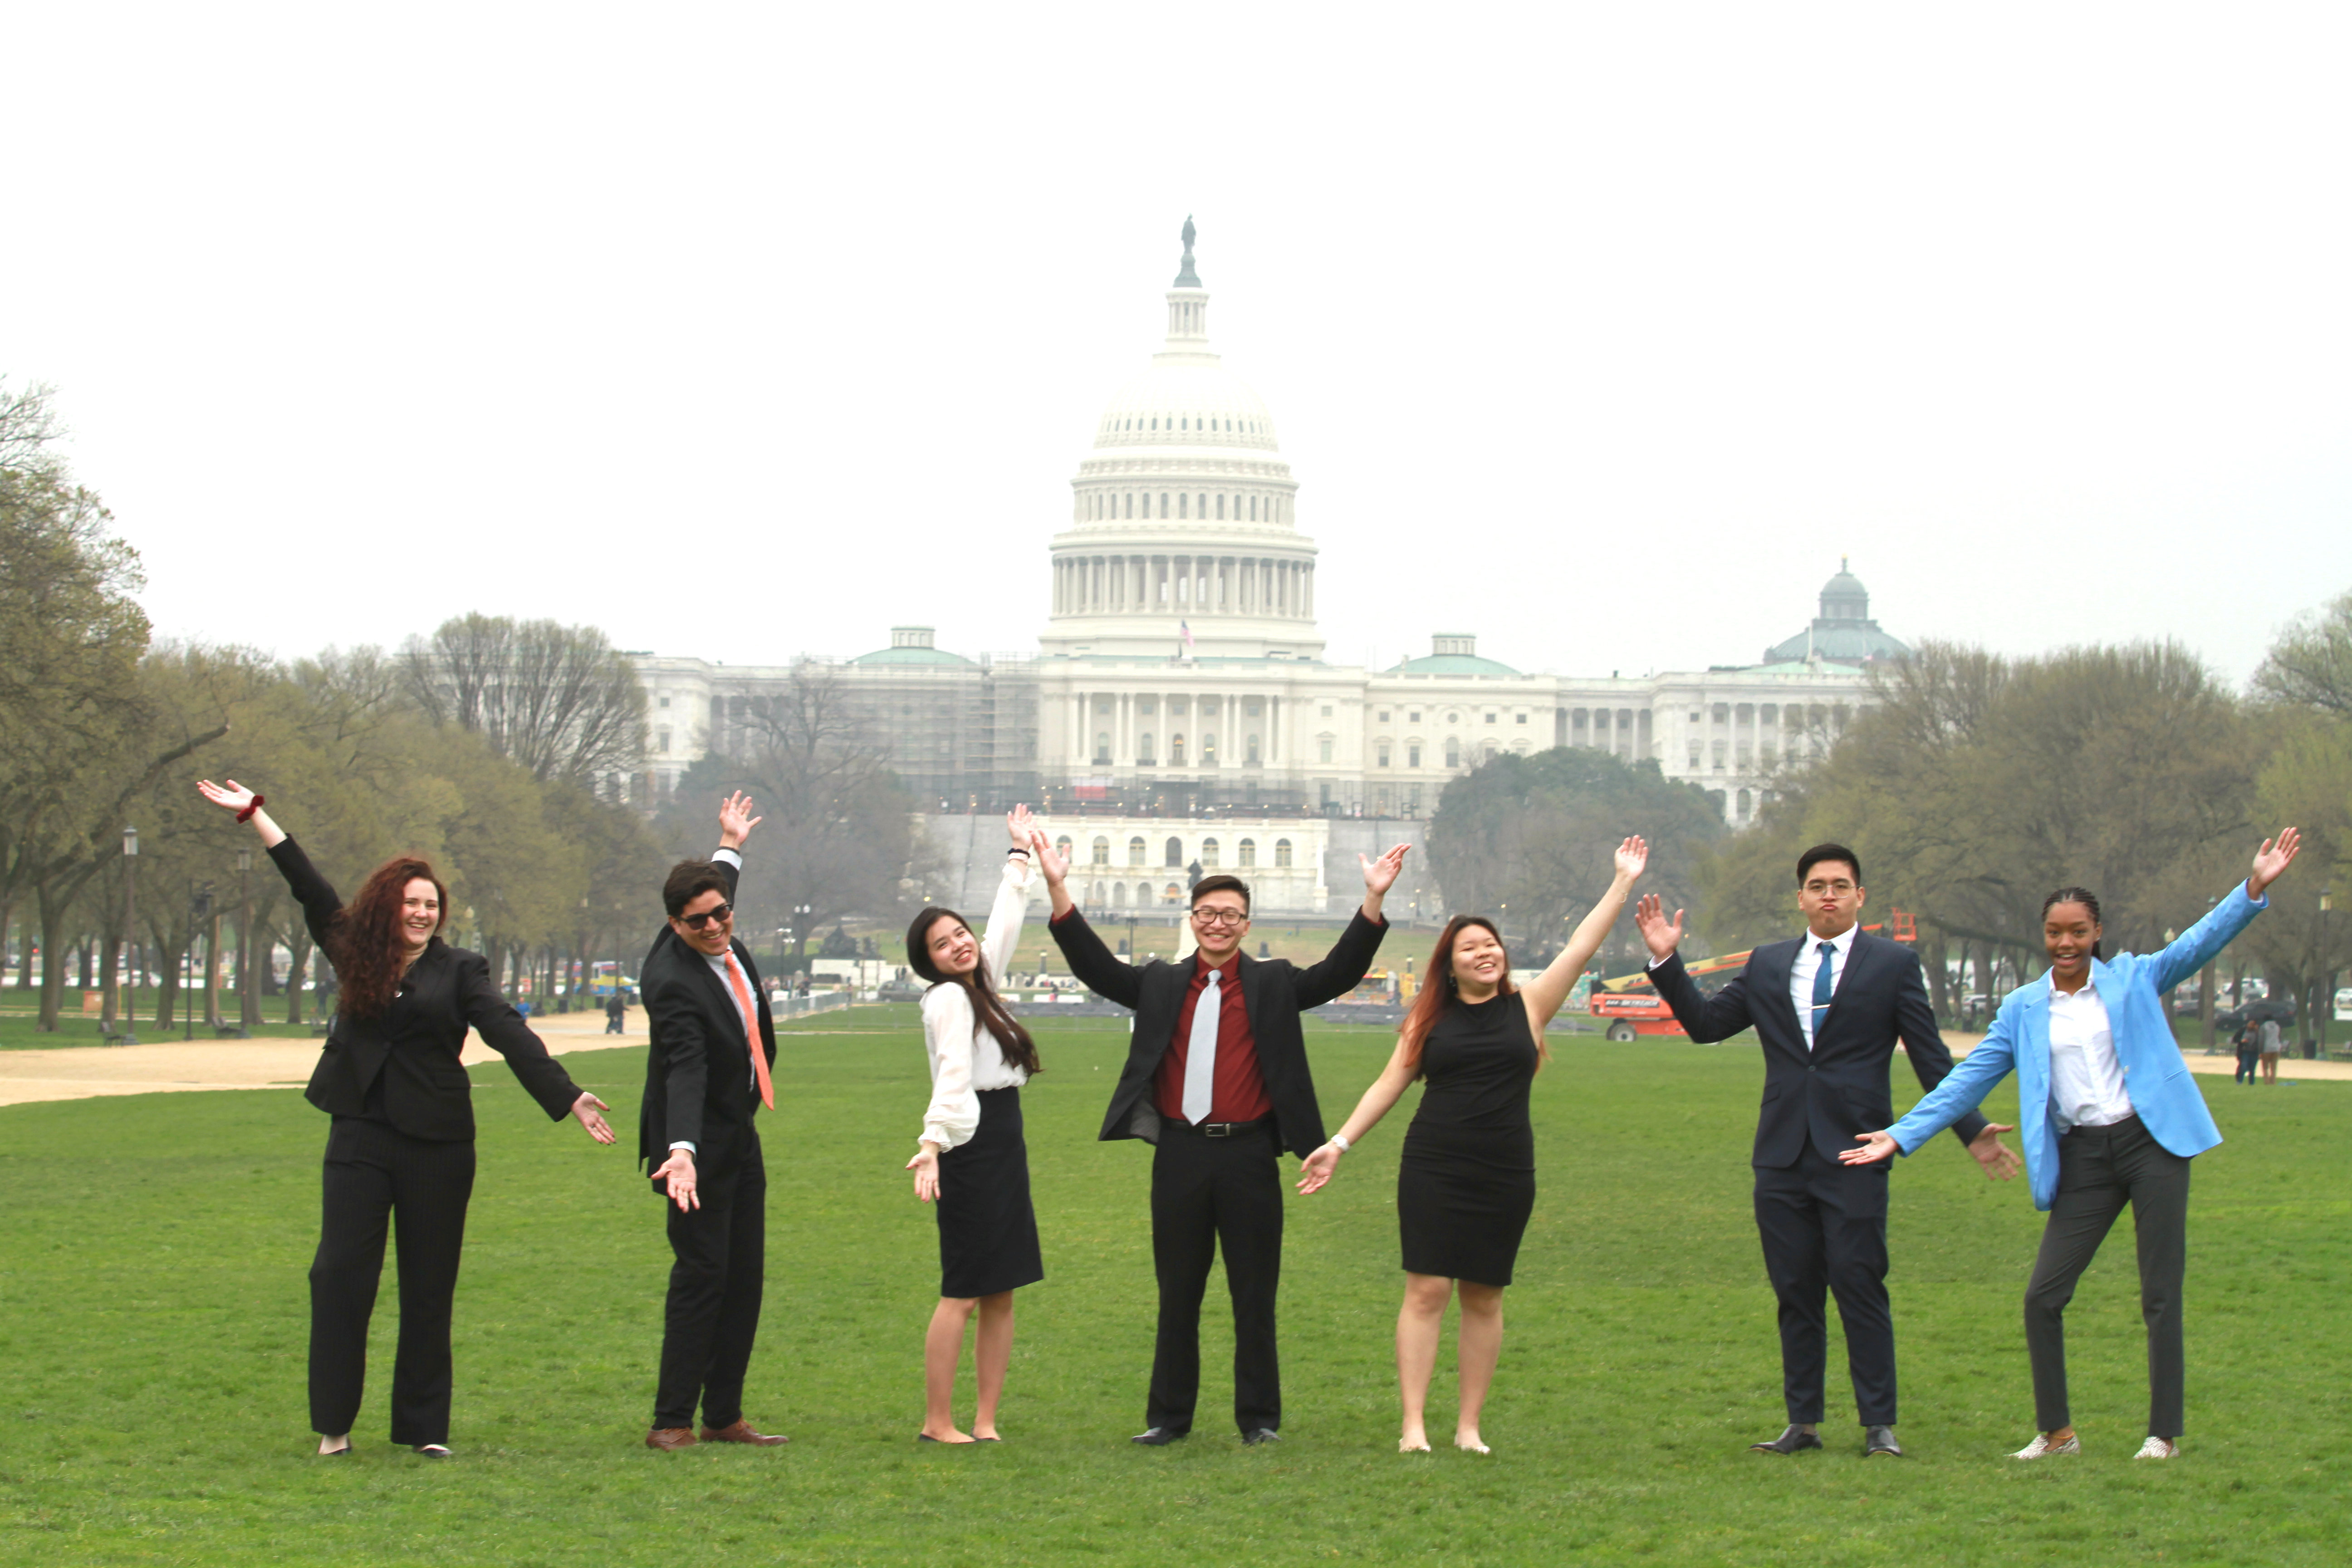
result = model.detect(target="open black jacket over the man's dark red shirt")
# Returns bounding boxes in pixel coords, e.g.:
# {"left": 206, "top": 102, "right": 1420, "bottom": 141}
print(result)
{"left": 1051, "top": 910, "right": 1388, "bottom": 1159}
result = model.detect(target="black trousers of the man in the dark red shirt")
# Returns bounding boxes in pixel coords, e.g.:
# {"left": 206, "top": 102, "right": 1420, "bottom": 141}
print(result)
{"left": 1143, "top": 1119, "right": 1282, "bottom": 1431}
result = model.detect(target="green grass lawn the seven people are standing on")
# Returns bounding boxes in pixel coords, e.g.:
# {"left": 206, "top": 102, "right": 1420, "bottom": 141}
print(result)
{"left": 0, "top": 1011, "right": 2352, "bottom": 1566}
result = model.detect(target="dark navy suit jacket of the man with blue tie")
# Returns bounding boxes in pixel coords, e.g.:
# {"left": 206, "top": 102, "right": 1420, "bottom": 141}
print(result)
{"left": 1649, "top": 931, "right": 1985, "bottom": 1171}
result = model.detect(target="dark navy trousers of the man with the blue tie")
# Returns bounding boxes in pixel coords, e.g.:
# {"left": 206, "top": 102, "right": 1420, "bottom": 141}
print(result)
{"left": 1757, "top": 1142, "right": 1896, "bottom": 1427}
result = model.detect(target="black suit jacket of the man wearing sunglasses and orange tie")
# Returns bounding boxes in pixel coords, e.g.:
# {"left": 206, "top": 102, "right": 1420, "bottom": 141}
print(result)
{"left": 637, "top": 860, "right": 776, "bottom": 1192}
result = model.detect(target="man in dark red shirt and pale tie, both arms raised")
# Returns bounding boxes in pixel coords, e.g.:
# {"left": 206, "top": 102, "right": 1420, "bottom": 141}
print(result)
{"left": 1033, "top": 832, "right": 1409, "bottom": 1448}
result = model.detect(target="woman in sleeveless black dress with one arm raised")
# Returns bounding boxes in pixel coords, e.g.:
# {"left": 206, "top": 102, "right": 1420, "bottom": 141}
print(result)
{"left": 1298, "top": 839, "right": 1649, "bottom": 1453}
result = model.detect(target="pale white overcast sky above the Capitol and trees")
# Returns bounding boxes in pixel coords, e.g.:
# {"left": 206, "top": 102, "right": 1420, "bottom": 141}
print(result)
{"left": 0, "top": 2, "right": 2352, "bottom": 682}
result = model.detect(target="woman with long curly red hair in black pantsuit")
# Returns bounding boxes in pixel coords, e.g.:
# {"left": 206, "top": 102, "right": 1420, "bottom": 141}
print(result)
{"left": 195, "top": 778, "right": 612, "bottom": 1457}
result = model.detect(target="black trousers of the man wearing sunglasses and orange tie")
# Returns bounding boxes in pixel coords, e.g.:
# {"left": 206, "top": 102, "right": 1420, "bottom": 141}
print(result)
{"left": 654, "top": 1128, "right": 767, "bottom": 1427}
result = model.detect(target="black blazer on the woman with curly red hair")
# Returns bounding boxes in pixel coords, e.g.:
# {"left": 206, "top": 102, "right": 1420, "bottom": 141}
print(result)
{"left": 270, "top": 839, "right": 581, "bottom": 1142}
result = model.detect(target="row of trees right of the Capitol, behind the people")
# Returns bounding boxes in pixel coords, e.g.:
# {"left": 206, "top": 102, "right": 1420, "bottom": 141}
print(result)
{"left": 1428, "top": 593, "right": 2352, "bottom": 1039}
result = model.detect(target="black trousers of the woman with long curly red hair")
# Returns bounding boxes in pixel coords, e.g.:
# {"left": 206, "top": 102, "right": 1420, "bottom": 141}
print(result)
{"left": 310, "top": 1117, "right": 473, "bottom": 1446}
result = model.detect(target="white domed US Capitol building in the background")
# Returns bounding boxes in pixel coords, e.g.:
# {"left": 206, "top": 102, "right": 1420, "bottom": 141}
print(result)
{"left": 632, "top": 221, "right": 1907, "bottom": 912}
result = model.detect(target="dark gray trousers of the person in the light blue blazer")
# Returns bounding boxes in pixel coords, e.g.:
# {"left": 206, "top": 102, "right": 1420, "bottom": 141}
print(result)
{"left": 2025, "top": 1117, "right": 2190, "bottom": 1439}
